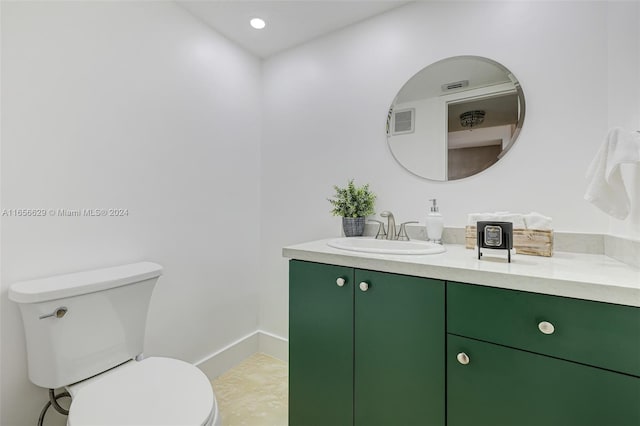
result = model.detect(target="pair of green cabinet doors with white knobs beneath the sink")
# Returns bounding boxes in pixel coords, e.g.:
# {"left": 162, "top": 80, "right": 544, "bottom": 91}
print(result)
{"left": 289, "top": 260, "right": 445, "bottom": 426}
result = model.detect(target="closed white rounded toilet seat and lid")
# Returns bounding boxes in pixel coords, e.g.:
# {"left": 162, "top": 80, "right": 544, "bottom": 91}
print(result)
{"left": 67, "top": 357, "right": 219, "bottom": 426}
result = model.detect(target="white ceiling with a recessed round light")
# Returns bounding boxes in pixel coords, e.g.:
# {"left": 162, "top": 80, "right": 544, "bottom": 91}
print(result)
{"left": 176, "top": 0, "right": 410, "bottom": 58}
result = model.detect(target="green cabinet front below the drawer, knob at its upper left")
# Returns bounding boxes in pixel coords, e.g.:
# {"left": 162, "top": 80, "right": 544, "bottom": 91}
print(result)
{"left": 447, "top": 334, "right": 640, "bottom": 426}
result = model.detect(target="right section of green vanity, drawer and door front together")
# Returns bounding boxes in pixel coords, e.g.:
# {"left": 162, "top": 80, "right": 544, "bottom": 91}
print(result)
{"left": 447, "top": 282, "right": 640, "bottom": 426}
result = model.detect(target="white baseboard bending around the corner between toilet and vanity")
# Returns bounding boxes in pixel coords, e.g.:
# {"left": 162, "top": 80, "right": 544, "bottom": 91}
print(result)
{"left": 195, "top": 330, "right": 289, "bottom": 380}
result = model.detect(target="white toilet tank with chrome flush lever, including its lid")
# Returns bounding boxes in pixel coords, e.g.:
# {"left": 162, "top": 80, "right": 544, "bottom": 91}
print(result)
{"left": 9, "top": 262, "right": 162, "bottom": 388}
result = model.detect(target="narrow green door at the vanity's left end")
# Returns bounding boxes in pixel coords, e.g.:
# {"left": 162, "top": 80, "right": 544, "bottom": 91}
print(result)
{"left": 289, "top": 260, "right": 353, "bottom": 426}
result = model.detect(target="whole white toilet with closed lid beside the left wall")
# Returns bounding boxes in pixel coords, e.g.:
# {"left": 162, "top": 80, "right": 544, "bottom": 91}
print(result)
{"left": 9, "top": 262, "right": 220, "bottom": 426}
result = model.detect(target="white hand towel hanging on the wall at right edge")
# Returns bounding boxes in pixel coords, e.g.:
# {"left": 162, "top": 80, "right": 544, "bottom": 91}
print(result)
{"left": 584, "top": 127, "right": 640, "bottom": 219}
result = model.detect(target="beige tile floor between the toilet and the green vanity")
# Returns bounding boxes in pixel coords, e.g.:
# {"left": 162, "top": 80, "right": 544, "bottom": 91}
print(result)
{"left": 212, "top": 353, "right": 288, "bottom": 426}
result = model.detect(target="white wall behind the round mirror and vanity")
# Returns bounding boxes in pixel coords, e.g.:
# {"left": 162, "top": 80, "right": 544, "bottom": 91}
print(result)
{"left": 260, "top": 2, "right": 637, "bottom": 336}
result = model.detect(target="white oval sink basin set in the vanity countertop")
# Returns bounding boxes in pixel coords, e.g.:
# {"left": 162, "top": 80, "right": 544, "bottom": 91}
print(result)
{"left": 327, "top": 237, "right": 446, "bottom": 254}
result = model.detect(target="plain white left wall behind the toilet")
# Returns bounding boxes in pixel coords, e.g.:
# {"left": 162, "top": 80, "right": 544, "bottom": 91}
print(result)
{"left": 0, "top": 2, "right": 261, "bottom": 426}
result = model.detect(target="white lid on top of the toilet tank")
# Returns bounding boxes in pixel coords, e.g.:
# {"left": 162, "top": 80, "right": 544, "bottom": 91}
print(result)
{"left": 9, "top": 262, "right": 162, "bottom": 303}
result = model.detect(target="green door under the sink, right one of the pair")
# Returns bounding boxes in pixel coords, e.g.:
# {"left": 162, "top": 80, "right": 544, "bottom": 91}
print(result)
{"left": 356, "top": 269, "right": 445, "bottom": 426}
